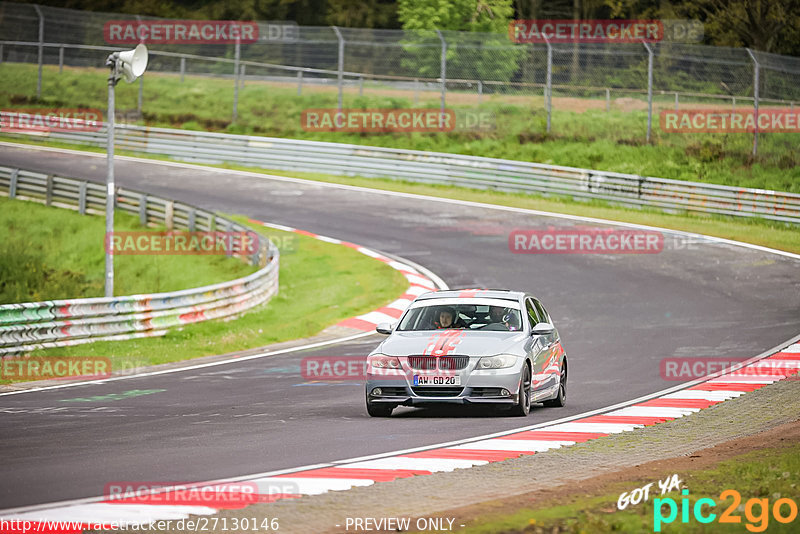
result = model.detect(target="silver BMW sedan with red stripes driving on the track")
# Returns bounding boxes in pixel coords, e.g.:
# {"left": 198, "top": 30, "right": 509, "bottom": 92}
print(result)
{"left": 365, "top": 289, "right": 567, "bottom": 417}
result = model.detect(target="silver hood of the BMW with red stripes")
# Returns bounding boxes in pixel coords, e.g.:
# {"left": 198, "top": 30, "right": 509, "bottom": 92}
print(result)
{"left": 374, "top": 330, "right": 527, "bottom": 356}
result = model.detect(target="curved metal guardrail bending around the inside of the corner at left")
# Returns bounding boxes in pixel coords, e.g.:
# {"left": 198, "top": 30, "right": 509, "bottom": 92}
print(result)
{"left": 0, "top": 167, "right": 279, "bottom": 357}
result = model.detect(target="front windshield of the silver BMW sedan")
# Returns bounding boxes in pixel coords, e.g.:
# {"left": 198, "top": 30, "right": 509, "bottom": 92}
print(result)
{"left": 397, "top": 302, "right": 522, "bottom": 332}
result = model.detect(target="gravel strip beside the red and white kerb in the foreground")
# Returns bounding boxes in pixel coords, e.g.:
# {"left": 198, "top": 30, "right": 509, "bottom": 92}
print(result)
{"left": 166, "top": 378, "right": 800, "bottom": 533}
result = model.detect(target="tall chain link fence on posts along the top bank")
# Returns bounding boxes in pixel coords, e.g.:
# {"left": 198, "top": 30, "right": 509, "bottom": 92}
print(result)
{"left": 0, "top": 2, "right": 800, "bottom": 150}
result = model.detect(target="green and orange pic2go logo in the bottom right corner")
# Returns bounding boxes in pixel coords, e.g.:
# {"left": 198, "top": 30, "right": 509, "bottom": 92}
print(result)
{"left": 653, "top": 489, "right": 797, "bottom": 532}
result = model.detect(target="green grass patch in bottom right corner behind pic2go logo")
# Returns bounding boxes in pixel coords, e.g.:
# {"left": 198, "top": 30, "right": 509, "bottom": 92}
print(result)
{"left": 444, "top": 445, "right": 800, "bottom": 534}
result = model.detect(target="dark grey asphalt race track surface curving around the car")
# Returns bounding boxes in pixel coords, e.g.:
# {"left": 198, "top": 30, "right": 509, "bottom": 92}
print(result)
{"left": 0, "top": 146, "right": 800, "bottom": 509}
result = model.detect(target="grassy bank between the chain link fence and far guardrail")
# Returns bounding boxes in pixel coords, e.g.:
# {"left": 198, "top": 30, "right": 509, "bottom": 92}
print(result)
{"left": 0, "top": 63, "right": 800, "bottom": 192}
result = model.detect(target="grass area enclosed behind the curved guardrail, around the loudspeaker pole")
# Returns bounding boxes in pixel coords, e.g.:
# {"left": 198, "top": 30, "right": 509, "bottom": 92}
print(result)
{"left": 0, "top": 197, "right": 255, "bottom": 303}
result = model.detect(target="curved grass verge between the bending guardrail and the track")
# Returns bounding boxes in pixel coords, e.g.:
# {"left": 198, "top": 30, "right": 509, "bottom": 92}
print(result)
{"left": 13, "top": 217, "right": 408, "bottom": 383}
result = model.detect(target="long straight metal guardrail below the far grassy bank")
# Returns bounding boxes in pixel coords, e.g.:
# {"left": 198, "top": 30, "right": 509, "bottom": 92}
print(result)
{"left": 3, "top": 119, "right": 800, "bottom": 223}
